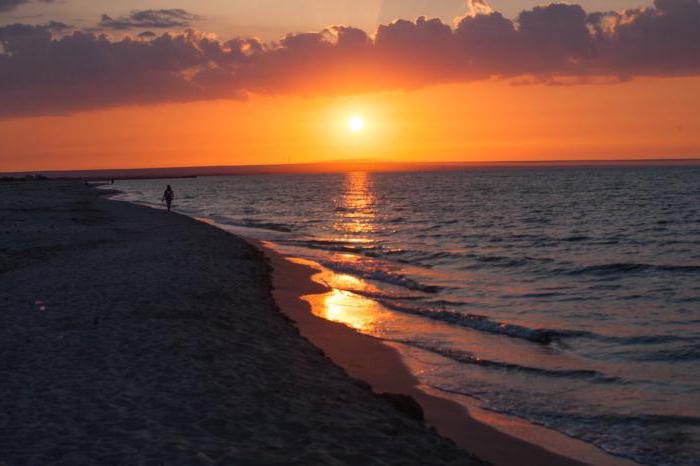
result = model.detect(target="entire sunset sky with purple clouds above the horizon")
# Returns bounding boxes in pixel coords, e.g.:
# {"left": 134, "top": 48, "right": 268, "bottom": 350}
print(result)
{"left": 0, "top": 0, "right": 700, "bottom": 171}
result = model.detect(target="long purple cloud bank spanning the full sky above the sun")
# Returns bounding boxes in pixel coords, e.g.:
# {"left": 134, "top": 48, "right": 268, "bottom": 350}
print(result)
{"left": 0, "top": 0, "right": 700, "bottom": 117}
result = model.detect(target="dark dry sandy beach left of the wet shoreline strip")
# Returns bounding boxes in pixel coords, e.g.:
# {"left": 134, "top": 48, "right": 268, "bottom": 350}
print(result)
{"left": 0, "top": 182, "right": 478, "bottom": 465}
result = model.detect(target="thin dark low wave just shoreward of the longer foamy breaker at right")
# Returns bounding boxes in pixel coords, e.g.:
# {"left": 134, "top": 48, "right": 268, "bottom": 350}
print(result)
{"left": 400, "top": 340, "right": 627, "bottom": 383}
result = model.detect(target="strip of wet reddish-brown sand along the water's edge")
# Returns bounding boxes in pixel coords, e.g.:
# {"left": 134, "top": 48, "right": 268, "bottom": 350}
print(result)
{"left": 254, "top": 237, "right": 637, "bottom": 466}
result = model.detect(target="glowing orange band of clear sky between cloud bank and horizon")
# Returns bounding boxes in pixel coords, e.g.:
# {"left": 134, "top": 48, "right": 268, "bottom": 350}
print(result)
{"left": 0, "top": 78, "right": 700, "bottom": 171}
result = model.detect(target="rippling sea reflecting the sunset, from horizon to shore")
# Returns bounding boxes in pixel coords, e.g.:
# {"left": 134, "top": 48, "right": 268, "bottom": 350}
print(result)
{"left": 110, "top": 167, "right": 700, "bottom": 465}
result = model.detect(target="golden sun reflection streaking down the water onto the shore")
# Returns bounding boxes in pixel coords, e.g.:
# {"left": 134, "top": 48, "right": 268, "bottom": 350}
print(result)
{"left": 294, "top": 172, "right": 568, "bottom": 352}
